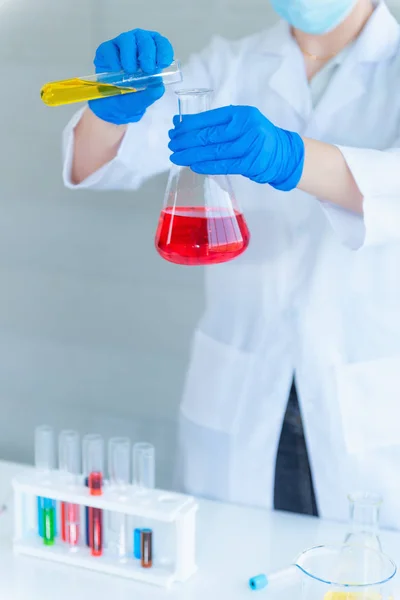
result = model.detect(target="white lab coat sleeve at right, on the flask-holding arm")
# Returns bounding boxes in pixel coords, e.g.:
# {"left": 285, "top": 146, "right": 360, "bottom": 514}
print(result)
{"left": 322, "top": 144, "right": 400, "bottom": 250}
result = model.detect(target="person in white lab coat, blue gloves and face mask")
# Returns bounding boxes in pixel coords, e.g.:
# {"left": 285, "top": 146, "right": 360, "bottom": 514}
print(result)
{"left": 64, "top": 0, "right": 400, "bottom": 528}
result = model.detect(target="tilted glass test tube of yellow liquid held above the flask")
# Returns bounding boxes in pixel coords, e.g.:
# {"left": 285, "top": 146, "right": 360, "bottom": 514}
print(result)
{"left": 40, "top": 60, "right": 182, "bottom": 106}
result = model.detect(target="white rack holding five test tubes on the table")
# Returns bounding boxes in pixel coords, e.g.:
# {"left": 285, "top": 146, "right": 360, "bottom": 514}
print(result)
{"left": 13, "top": 469, "right": 198, "bottom": 587}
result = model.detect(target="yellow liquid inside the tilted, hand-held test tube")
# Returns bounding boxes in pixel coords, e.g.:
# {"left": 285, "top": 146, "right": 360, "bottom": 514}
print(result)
{"left": 40, "top": 77, "right": 136, "bottom": 106}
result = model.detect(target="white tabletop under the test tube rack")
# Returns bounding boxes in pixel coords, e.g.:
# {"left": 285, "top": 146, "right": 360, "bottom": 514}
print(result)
{"left": 0, "top": 461, "right": 400, "bottom": 600}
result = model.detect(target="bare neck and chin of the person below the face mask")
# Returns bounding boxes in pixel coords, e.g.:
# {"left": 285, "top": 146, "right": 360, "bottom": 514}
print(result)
{"left": 293, "top": 0, "right": 375, "bottom": 66}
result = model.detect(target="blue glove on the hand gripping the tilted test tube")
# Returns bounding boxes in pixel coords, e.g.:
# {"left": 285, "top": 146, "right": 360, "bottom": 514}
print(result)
{"left": 89, "top": 29, "right": 174, "bottom": 125}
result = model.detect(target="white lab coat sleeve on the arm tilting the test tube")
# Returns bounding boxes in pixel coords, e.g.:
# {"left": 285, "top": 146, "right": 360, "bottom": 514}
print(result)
{"left": 63, "top": 37, "right": 229, "bottom": 190}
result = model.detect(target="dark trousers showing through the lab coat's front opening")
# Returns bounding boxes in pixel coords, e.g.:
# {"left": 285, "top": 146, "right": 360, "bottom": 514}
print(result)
{"left": 274, "top": 384, "right": 318, "bottom": 516}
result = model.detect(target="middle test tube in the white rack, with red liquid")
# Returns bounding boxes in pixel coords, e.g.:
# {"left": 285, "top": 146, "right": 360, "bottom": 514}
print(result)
{"left": 83, "top": 434, "right": 104, "bottom": 556}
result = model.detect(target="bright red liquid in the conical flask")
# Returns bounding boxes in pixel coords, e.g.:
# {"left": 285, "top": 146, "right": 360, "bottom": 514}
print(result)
{"left": 156, "top": 206, "right": 250, "bottom": 266}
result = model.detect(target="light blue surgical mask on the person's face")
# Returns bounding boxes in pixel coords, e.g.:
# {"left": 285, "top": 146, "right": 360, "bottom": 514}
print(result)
{"left": 271, "top": 0, "right": 357, "bottom": 35}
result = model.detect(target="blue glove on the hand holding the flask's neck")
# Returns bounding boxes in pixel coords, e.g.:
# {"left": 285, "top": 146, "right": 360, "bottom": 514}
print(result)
{"left": 169, "top": 106, "right": 304, "bottom": 191}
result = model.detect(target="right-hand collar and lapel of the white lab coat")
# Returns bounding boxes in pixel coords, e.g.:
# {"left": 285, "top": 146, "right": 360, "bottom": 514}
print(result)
{"left": 313, "top": 2, "right": 400, "bottom": 130}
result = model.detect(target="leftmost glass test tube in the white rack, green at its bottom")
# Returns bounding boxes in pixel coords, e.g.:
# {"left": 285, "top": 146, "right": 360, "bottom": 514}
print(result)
{"left": 35, "top": 425, "right": 57, "bottom": 546}
